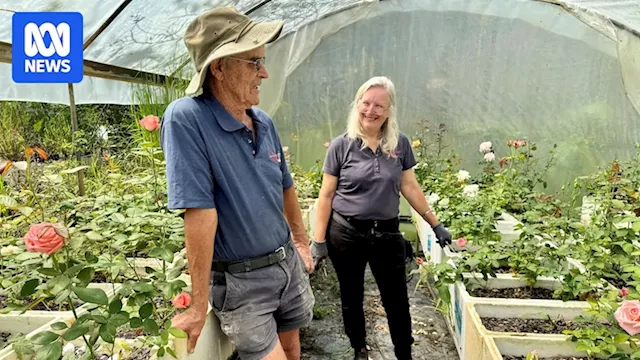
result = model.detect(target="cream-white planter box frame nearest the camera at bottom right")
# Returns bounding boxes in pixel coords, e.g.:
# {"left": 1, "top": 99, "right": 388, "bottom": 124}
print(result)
{"left": 463, "top": 302, "right": 585, "bottom": 355}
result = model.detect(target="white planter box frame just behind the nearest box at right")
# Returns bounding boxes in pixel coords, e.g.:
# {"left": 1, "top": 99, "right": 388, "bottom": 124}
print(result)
{"left": 445, "top": 274, "right": 589, "bottom": 359}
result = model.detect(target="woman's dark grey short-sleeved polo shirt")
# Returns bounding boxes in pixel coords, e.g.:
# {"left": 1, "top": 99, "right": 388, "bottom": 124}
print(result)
{"left": 323, "top": 133, "right": 416, "bottom": 220}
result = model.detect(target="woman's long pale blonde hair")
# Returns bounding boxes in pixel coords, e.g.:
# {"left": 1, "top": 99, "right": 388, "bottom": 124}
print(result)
{"left": 347, "top": 76, "right": 400, "bottom": 157}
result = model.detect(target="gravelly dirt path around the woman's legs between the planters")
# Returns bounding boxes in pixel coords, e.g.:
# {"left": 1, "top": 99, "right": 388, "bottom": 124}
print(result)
{"left": 300, "top": 260, "right": 459, "bottom": 360}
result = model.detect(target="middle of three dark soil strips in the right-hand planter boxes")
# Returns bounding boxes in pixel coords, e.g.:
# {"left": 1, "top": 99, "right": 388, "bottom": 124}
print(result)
{"left": 482, "top": 318, "right": 580, "bottom": 334}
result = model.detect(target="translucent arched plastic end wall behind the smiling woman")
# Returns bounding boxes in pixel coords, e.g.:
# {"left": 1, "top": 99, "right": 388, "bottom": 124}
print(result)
{"left": 262, "top": 0, "right": 640, "bottom": 188}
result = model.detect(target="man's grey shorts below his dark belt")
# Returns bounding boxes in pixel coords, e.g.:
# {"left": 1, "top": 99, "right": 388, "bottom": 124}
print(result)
{"left": 209, "top": 244, "right": 315, "bottom": 360}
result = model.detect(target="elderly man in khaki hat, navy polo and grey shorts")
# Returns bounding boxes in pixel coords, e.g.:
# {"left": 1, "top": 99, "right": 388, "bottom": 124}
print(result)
{"left": 161, "top": 8, "right": 314, "bottom": 360}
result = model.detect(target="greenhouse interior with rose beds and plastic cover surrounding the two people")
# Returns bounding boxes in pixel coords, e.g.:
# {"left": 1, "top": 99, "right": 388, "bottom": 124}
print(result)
{"left": 0, "top": 0, "right": 640, "bottom": 360}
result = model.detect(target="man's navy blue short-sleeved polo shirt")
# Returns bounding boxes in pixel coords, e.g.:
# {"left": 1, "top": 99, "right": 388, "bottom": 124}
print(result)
{"left": 160, "top": 95, "right": 293, "bottom": 260}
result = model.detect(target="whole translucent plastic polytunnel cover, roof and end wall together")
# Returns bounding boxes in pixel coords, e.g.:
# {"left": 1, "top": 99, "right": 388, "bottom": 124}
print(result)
{"left": 0, "top": 0, "right": 640, "bottom": 186}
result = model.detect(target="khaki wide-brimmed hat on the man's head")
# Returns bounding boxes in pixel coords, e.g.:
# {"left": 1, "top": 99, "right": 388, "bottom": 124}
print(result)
{"left": 184, "top": 7, "right": 284, "bottom": 95}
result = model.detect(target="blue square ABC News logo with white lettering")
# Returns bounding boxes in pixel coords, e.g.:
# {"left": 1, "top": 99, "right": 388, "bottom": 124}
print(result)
{"left": 12, "top": 12, "right": 84, "bottom": 83}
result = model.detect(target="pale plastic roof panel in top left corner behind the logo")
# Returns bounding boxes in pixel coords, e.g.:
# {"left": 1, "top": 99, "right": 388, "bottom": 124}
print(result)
{"left": 0, "top": 0, "right": 122, "bottom": 44}
